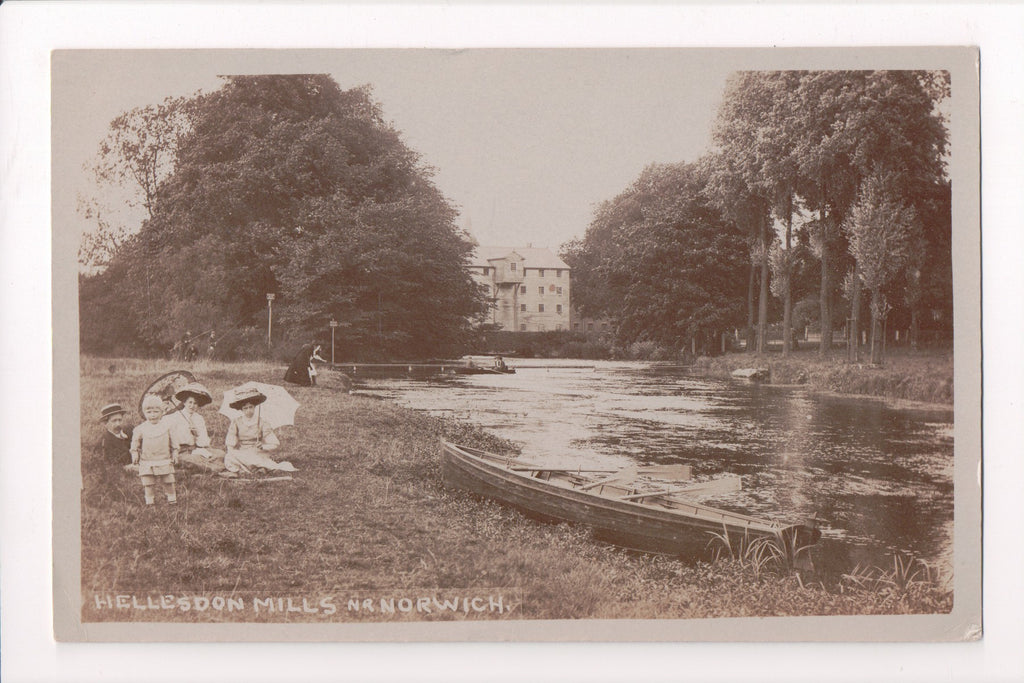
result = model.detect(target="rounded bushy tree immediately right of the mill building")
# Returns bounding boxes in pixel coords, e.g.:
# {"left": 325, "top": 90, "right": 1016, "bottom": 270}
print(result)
{"left": 573, "top": 164, "right": 746, "bottom": 349}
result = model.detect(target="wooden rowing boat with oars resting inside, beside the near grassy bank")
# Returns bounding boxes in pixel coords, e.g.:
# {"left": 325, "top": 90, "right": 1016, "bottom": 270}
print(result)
{"left": 441, "top": 441, "right": 821, "bottom": 559}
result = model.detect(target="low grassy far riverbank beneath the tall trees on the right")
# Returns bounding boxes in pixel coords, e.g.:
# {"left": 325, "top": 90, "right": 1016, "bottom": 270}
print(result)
{"left": 693, "top": 349, "right": 953, "bottom": 405}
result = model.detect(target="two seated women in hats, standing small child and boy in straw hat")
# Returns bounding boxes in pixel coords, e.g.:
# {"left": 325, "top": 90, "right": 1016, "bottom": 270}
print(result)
{"left": 99, "top": 382, "right": 295, "bottom": 505}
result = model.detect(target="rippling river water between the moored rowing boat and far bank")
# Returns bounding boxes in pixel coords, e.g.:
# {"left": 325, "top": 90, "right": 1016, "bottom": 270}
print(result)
{"left": 356, "top": 360, "right": 953, "bottom": 570}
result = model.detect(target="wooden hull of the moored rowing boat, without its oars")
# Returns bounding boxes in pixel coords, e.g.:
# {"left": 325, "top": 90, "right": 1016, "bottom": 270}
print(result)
{"left": 442, "top": 442, "right": 818, "bottom": 558}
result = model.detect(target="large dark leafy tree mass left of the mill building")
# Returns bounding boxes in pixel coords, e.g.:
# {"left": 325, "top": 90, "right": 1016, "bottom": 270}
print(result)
{"left": 80, "top": 75, "right": 485, "bottom": 357}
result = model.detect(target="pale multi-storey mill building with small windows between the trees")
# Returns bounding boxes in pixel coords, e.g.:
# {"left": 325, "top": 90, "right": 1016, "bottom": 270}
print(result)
{"left": 469, "top": 247, "right": 572, "bottom": 332}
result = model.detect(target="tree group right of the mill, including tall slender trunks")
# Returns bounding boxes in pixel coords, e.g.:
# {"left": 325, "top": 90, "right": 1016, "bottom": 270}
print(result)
{"left": 563, "top": 71, "right": 952, "bottom": 360}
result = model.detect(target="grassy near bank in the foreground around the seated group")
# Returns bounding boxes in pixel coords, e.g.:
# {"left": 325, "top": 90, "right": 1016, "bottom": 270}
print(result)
{"left": 81, "top": 358, "right": 952, "bottom": 622}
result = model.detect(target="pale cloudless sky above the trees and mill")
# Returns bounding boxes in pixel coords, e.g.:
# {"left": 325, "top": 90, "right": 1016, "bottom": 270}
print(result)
{"left": 53, "top": 49, "right": 733, "bottom": 251}
